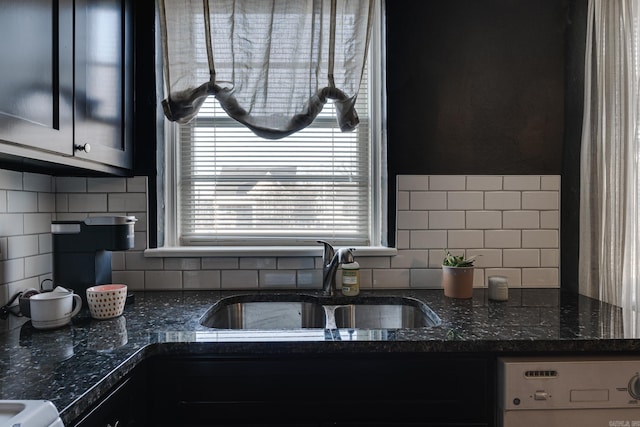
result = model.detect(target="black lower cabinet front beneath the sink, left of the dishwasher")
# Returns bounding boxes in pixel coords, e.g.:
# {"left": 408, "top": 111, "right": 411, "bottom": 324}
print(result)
{"left": 146, "top": 353, "right": 495, "bottom": 427}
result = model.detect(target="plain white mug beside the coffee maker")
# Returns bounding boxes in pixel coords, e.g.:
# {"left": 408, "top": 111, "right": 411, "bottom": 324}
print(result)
{"left": 29, "top": 291, "right": 82, "bottom": 329}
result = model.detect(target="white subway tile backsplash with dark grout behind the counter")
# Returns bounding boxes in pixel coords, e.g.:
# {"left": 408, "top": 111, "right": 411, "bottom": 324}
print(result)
{"left": 0, "top": 170, "right": 560, "bottom": 298}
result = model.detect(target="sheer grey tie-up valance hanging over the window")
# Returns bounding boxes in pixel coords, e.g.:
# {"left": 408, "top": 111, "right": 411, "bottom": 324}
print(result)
{"left": 158, "top": 0, "right": 373, "bottom": 139}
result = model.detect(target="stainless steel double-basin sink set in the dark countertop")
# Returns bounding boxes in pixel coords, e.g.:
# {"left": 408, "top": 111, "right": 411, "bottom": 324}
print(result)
{"left": 200, "top": 294, "right": 441, "bottom": 330}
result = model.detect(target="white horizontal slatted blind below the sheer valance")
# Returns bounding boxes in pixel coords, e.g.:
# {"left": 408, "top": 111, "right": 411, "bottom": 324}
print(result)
{"left": 179, "top": 77, "right": 371, "bottom": 246}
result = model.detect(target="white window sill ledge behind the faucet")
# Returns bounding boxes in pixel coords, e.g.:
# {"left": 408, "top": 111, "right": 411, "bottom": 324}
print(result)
{"left": 144, "top": 246, "right": 398, "bottom": 258}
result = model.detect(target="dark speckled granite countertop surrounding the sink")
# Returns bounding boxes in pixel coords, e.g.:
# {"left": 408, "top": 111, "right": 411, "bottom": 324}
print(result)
{"left": 0, "top": 289, "right": 640, "bottom": 424}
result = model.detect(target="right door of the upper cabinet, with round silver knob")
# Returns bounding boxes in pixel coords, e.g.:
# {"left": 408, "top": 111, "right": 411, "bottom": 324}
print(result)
{"left": 74, "top": 0, "right": 133, "bottom": 169}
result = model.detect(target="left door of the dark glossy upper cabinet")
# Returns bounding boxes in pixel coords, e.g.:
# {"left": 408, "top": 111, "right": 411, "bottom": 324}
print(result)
{"left": 0, "top": 0, "right": 73, "bottom": 155}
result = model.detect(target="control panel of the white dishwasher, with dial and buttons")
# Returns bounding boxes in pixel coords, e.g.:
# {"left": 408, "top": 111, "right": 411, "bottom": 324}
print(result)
{"left": 498, "top": 356, "right": 640, "bottom": 411}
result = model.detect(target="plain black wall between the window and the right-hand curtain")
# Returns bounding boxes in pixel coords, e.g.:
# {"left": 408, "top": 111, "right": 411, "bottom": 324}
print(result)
{"left": 386, "top": 0, "right": 587, "bottom": 287}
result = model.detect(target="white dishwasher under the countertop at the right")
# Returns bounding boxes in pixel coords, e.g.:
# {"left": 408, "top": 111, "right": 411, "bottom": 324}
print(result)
{"left": 496, "top": 356, "right": 640, "bottom": 427}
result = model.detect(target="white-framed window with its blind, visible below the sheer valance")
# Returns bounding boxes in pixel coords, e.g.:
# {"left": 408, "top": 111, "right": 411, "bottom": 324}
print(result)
{"left": 163, "top": 2, "right": 387, "bottom": 252}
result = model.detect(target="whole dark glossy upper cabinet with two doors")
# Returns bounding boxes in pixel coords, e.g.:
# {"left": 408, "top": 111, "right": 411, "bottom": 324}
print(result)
{"left": 0, "top": 0, "right": 134, "bottom": 175}
